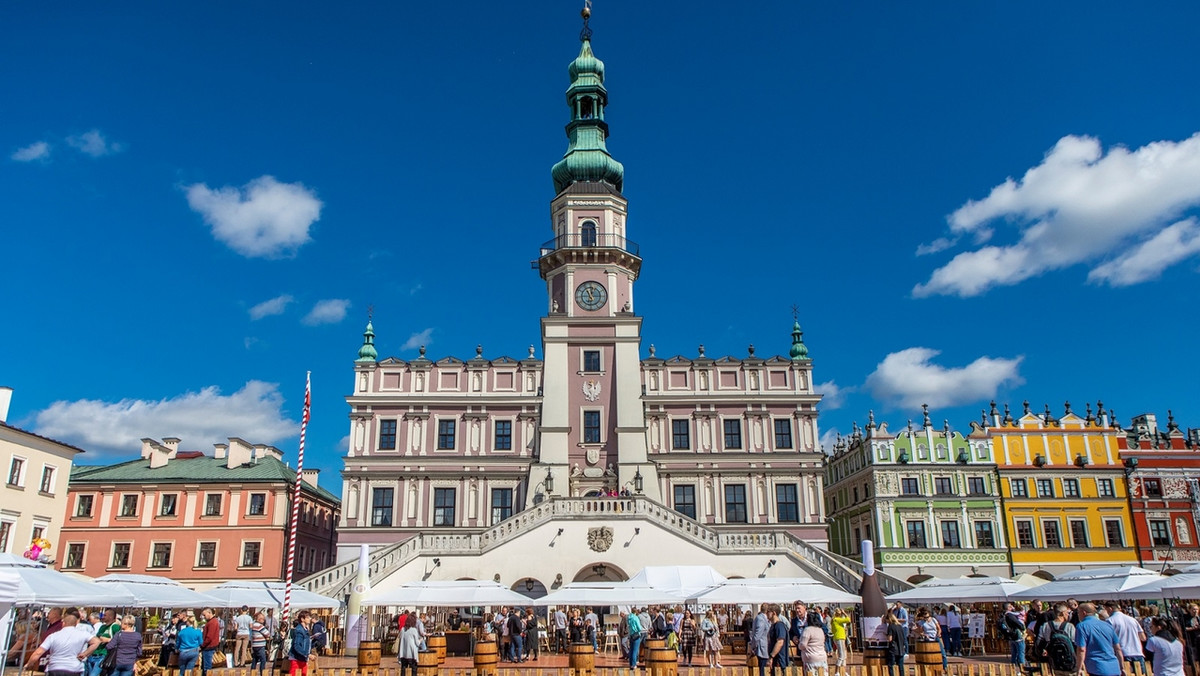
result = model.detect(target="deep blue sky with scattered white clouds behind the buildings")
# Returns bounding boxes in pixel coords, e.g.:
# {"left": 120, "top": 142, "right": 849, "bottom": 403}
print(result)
{"left": 0, "top": 0, "right": 1200, "bottom": 489}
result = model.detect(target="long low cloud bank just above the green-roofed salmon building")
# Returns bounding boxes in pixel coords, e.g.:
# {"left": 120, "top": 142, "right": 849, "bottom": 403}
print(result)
{"left": 35, "top": 381, "right": 300, "bottom": 461}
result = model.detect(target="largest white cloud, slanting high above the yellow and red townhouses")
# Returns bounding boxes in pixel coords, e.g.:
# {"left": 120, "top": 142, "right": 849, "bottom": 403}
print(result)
{"left": 913, "top": 133, "right": 1200, "bottom": 297}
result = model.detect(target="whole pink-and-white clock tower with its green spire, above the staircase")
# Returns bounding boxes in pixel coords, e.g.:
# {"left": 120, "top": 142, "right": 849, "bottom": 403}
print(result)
{"left": 529, "top": 10, "right": 661, "bottom": 501}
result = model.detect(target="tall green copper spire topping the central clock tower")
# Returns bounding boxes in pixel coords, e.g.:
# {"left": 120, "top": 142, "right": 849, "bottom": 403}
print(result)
{"left": 550, "top": 8, "right": 625, "bottom": 195}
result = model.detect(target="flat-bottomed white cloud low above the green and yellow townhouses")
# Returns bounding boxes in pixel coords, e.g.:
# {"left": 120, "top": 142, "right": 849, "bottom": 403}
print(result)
{"left": 866, "top": 347, "right": 1025, "bottom": 408}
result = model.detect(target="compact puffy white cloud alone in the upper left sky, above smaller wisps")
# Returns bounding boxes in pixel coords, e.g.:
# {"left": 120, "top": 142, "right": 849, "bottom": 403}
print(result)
{"left": 187, "top": 177, "right": 323, "bottom": 258}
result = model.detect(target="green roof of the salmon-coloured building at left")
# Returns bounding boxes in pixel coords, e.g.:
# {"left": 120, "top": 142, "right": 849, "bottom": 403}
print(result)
{"left": 71, "top": 451, "right": 342, "bottom": 503}
